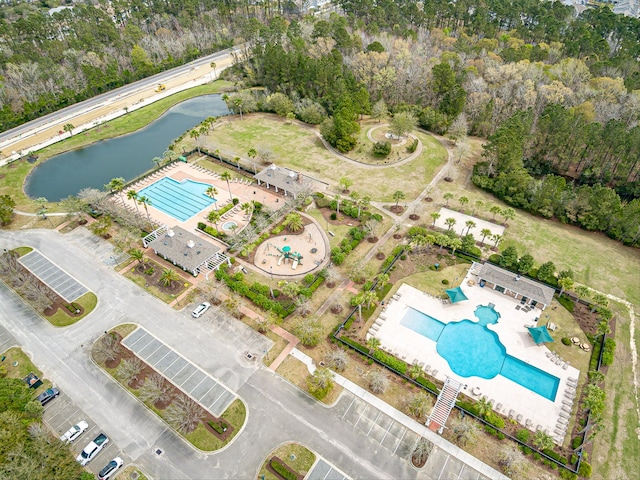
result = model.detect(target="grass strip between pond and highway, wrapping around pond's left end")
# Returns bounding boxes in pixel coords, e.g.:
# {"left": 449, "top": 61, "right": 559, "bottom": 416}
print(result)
{"left": 0, "top": 80, "right": 231, "bottom": 213}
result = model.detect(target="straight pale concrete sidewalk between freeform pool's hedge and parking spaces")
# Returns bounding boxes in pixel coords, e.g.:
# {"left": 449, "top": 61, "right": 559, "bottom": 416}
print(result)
{"left": 291, "top": 348, "right": 509, "bottom": 480}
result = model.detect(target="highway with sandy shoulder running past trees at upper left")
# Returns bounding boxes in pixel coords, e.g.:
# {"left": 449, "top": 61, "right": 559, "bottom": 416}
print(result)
{"left": 0, "top": 46, "right": 245, "bottom": 164}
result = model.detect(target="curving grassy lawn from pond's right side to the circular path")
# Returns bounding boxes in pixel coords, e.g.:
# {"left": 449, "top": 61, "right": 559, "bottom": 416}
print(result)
{"left": 182, "top": 114, "right": 446, "bottom": 202}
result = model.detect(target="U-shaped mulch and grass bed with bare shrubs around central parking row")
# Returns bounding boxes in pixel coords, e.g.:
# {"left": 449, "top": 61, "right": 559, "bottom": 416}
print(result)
{"left": 92, "top": 325, "right": 246, "bottom": 452}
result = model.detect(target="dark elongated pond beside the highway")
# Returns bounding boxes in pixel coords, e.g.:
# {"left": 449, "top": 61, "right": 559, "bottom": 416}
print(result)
{"left": 24, "top": 95, "right": 229, "bottom": 202}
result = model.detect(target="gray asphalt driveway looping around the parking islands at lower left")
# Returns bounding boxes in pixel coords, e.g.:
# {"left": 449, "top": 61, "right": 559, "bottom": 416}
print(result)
{"left": 0, "top": 230, "right": 426, "bottom": 479}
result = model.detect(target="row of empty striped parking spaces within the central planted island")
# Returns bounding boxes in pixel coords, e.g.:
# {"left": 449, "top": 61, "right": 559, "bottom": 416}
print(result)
{"left": 122, "top": 328, "right": 236, "bottom": 417}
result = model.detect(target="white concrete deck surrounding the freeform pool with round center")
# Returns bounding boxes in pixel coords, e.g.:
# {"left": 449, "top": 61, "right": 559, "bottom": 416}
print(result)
{"left": 367, "top": 273, "right": 580, "bottom": 444}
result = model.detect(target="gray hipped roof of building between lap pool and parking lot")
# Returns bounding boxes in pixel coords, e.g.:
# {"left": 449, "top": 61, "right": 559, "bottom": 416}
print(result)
{"left": 149, "top": 226, "right": 220, "bottom": 272}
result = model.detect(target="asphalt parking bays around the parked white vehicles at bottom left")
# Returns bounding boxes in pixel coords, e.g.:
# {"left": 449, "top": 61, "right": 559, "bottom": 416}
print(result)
{"left": 42, "top": 392, "right": 126, "bottom": 474}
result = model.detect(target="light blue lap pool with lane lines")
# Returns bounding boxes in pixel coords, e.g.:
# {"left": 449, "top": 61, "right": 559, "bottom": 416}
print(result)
{"left": 138, "top": 177, "right": 216, "bottom": 222}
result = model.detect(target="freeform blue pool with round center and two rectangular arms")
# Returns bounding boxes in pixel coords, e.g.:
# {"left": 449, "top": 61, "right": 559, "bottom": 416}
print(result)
{"left": 400, "top": 305, "right": 560, "bottom": 401}
